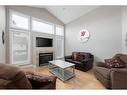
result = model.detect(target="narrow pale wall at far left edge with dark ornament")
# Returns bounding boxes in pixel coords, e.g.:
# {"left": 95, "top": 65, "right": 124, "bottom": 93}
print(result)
{"left": 0, "top": 6, "right": 6, "bottom": 63}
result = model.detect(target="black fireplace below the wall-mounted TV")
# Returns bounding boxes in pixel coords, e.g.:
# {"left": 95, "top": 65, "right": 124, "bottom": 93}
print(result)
{"left": 39, "top": 53, "right": 53, "bottom": 66}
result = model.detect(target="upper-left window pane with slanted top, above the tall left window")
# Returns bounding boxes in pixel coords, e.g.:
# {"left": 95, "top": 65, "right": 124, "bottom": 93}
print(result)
{"left": 10, "top": 12, "right": 29, "bottom": 30}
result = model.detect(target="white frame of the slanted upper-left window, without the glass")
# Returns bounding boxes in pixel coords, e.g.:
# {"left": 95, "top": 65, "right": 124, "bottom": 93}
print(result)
{"left": 9, "top": 10, "right": 30, "bottom": 30}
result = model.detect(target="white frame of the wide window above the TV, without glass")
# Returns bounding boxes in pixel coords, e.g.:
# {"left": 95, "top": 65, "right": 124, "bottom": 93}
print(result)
{"left": 31, "top": 17, "right": 55, "bottom": 35}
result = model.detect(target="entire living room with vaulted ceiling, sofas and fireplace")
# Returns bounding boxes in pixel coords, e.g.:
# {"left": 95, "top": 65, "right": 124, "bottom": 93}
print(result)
{"left": 0, "top": 5, "right": 127, "bottom": 90}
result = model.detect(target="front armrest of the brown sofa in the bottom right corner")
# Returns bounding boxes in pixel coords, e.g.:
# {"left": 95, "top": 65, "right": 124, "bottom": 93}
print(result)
{"left": 110, "top": 68, "right": 127, "bottom": 89}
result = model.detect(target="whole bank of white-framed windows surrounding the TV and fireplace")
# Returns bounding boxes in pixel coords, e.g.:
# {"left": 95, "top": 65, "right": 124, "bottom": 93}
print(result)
{"left": 9, "top": 11, "right": 64, "bottom": 65}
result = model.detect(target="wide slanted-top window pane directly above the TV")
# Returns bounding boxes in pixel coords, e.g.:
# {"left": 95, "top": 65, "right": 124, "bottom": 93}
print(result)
{"left": 32, "top": 19, "right": 54, "bottom": 34}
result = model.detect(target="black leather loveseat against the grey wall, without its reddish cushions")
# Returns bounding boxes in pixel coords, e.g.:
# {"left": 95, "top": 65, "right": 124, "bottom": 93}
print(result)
{"left": 65, "top": 52, "right": 94, "bottom": 71}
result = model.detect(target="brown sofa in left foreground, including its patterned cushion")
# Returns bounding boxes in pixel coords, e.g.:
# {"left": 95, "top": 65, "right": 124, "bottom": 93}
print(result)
{"left": 0, "top": 64, "right": 56, "bottom": 89}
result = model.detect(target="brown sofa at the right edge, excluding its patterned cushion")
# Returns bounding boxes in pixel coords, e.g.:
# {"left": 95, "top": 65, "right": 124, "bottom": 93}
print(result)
{"left": 94, "top": 54, "right": 127, "bottom": 89}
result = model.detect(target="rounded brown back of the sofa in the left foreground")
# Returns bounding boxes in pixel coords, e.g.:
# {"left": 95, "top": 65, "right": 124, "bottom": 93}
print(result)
{"left": 0, "top": 64, "right": 32, "bottom": 89}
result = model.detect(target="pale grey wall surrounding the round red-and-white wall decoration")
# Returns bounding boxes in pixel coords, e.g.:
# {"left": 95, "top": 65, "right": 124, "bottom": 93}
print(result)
{"left": 65, "top": 6, "right": 122, "bottom": 62}
